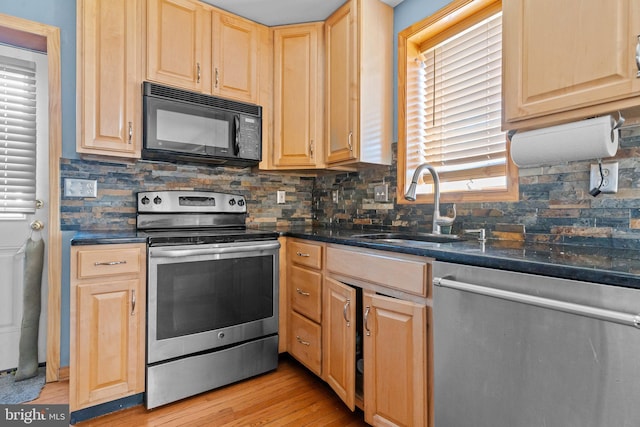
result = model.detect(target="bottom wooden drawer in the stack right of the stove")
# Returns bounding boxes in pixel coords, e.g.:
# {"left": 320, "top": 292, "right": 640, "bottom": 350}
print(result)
{"left": 289, "top": 311, "right": 322, "bottom": 375}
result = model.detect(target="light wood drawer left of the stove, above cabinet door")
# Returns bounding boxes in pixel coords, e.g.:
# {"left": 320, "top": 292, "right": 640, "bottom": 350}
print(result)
{"left": 75, "top": 245, "right": 145, "bottom": 279}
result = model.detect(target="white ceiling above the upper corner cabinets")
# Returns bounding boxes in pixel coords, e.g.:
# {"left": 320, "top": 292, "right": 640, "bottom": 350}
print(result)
{"left": 202, "top": 0, "right": 403, "bottom": 26}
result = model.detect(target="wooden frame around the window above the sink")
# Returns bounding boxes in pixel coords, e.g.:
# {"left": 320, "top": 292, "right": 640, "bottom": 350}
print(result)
{"left": 396, "top": 0, "right": 519, "bottom": 204}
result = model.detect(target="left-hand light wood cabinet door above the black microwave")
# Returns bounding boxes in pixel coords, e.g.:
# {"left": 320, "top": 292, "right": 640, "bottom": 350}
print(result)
{"left": 147, "top": 0, "right": 211, "bottom": 92}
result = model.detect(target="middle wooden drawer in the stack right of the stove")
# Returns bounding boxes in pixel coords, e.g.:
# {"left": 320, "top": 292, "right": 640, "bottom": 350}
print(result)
{"left": 289, "top": 265, "right": 322, "bottom": 323}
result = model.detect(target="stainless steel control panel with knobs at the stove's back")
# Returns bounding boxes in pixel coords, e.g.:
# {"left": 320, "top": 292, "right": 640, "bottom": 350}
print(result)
{"left": 138, "top": 190, "right": 247, "bottom": 213}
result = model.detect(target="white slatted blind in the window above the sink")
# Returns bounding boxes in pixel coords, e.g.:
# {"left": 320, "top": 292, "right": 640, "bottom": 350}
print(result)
{"left": 406, "top": 13, "right": 507, "bottom": 192}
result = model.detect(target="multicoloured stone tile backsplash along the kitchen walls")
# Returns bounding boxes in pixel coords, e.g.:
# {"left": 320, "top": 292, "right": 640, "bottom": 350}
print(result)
{"left": 60, "top": 132, "right": 640, "bottom": 249}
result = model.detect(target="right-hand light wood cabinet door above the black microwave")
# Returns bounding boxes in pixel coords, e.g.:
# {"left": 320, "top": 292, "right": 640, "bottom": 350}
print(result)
{"left": 211, "top": 10, "right": 259, "bottom": 103}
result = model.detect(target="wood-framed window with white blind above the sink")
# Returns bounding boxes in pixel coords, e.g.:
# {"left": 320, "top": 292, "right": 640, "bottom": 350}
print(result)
{"left": 398, "top": 0, "right": 517, "bottom": 203}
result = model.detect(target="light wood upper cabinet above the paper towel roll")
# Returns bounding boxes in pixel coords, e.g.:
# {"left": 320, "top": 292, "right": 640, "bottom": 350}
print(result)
{"left": 502, "top": 0, "right": 640, "bottom": 129}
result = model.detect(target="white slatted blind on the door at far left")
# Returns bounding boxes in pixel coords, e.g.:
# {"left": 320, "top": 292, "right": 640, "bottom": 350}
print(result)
{"left": 0, "top": 56, "right": 36, "bottom": 213}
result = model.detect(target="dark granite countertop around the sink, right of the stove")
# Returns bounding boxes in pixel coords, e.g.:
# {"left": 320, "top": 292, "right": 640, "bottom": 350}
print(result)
{"left": 281, "top": 228, "right": 640, "bottom": 289}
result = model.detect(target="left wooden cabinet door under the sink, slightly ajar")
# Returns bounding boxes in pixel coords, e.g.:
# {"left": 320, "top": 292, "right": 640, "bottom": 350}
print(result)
{"left": 322, "top": 277, "right": 356, "bottom": 411}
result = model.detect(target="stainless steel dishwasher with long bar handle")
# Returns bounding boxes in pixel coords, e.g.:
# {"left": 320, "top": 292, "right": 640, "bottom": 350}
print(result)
{"left": 433, "top": 262, "right": 640, "bottom": 427}
